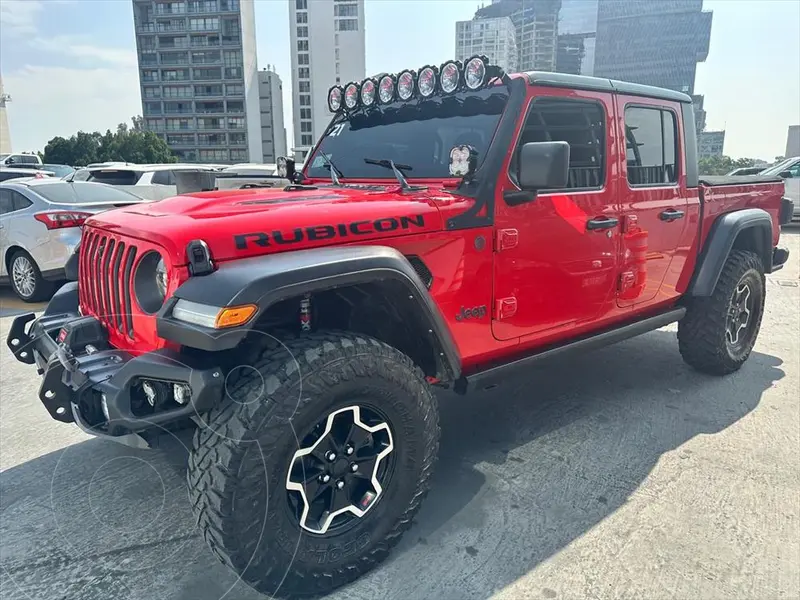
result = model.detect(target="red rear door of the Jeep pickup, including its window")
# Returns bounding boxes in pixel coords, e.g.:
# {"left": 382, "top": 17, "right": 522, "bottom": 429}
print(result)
{"left": 616, "top": 95, "right": 688, "bottom": 306}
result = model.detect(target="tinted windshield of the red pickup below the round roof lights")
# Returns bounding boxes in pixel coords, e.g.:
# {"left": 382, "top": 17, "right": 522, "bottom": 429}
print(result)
{"left": 305, "top": 86, "right": 508, "bottom": 179}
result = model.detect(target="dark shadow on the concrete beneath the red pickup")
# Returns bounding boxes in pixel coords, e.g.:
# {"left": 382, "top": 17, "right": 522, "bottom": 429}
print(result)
{"left": 0, "top": 330, "right": 784, "bottom": 600}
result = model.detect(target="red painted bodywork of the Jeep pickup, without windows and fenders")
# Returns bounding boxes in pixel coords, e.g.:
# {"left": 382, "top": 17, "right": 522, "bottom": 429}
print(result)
{"left": 80, "top": 79, "right": 783, "bottom": 374}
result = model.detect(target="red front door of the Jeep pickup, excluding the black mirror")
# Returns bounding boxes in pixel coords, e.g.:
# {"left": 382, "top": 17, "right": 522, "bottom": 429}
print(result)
{"left": 492, "top": 89, "right": 620, "bottom": 340}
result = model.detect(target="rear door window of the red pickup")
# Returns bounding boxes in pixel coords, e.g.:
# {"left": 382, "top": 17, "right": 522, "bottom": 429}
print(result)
{"left": 625, "top": 106, "right": 678, "bottom": 186}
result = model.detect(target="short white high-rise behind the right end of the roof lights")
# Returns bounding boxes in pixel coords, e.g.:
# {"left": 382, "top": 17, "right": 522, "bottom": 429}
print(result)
{"left": 455, "top": 17, "right": 517, "bottom": 73}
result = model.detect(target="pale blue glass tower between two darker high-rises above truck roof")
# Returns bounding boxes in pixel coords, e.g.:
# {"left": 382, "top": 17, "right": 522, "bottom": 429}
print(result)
{"left": 556, "top": 0, "right": 598, "bottom": 75}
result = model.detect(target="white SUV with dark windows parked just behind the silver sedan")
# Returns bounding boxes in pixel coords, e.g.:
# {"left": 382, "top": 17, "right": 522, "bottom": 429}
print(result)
{"left": 65, "top": 163, "right": 216, "bottom": 200}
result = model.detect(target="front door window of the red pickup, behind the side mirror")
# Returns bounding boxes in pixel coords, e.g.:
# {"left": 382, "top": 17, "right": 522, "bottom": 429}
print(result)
{"left": 514, "top": 98, "right": 606, "bottom": 190}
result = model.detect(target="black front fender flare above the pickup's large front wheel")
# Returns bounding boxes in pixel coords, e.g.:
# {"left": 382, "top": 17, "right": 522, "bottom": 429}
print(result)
{"left": 156, "top": 246, "right": 461, "bottom": 380}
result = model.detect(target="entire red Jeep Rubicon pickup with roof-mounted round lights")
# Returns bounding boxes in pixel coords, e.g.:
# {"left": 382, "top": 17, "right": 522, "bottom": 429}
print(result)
{"left": 8, "top": 57, "right": 792, "bottom": 595}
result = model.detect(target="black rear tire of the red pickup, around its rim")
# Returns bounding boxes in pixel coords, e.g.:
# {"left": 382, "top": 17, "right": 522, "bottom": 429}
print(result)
{"left": 678, "top": 250, "right": 766, "bottom": 375}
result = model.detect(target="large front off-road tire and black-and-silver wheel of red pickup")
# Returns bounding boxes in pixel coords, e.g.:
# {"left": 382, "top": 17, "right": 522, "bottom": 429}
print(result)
{"left": 188, "top": 332, "right": 439, "bottom": 596}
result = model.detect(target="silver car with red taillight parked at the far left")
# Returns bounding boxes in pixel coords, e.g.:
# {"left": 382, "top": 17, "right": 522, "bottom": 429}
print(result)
{"left": 0, "top": 177, "right": 145, "bottom": 302}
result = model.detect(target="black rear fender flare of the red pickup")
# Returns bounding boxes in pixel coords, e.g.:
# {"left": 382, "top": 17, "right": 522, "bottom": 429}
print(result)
{"left": 690, "top": 208, "right": 772, "bottom": 296}
